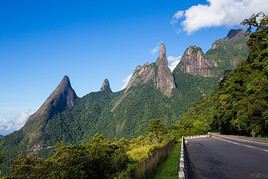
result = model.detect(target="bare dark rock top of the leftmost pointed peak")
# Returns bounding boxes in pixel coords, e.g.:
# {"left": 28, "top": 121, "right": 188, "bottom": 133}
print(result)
{"left": 28, "top": 76, "right": 78, "bottom": 121}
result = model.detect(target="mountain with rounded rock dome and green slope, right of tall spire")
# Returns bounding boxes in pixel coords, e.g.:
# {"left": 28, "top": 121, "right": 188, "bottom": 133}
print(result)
{"left": 173, "top": 29, "right": 248, "bottom": 114}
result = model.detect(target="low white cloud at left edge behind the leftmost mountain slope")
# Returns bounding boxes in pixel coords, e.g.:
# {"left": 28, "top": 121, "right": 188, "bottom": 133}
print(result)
{"left": 0, "top": 110, "right": 32, "bottom": 135}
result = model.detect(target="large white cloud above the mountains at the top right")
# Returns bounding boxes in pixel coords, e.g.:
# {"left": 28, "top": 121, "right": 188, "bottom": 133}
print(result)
{"left": 173, "top": 0, "right": 268, "bottom": 34}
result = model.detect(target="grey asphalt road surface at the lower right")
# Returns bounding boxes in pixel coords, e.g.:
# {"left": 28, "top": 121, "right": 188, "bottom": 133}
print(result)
{"left": 186, "top": 137, "right": 268, "bottom": 179}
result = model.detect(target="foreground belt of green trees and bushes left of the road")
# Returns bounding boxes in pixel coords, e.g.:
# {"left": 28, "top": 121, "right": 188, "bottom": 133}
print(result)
{"left": 0, "top": 120, "right": 180, "bottom": 179}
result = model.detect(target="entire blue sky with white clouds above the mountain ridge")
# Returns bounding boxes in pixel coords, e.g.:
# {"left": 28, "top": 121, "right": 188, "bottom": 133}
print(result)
{"left": 0, "top": 0, "right": 268, "bottom": 135}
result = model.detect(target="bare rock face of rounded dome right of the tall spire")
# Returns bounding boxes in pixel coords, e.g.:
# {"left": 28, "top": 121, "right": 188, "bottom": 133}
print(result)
{"left": 178, "top": 46, "right": 217, "bottom": 77}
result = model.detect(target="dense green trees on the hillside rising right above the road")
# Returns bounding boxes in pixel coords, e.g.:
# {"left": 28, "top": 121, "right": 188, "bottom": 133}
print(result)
{"left": 179, "top": 13, "right": 268, "bottom": 136}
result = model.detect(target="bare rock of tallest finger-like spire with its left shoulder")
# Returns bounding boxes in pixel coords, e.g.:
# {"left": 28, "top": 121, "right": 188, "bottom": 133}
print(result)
{"left": 125, "top": 43, "right": 175, "bottom": 97}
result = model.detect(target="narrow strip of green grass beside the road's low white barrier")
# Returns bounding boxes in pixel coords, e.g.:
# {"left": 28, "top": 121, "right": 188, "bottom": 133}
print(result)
{"left": 152, "top": 143, "right": 180, "bottom": 179}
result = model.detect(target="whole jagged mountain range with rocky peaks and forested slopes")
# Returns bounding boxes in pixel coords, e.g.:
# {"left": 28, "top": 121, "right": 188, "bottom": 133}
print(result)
{"left": 0, "top": 31, "right": 248, "bottom": 173}
